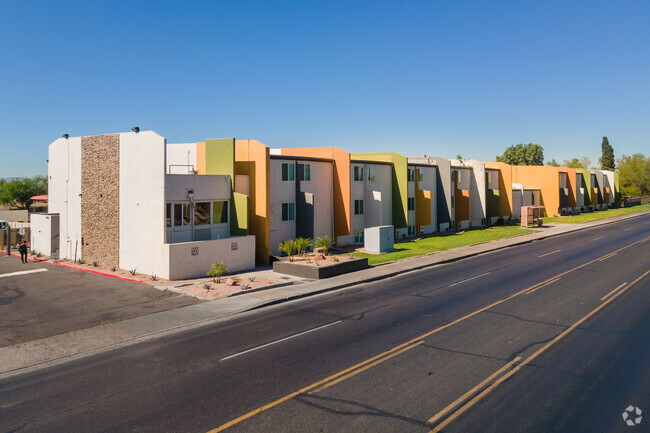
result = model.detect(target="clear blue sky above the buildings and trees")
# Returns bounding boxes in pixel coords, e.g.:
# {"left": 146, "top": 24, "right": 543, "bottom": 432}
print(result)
{"left": 0, "top": 0, "right": 650, "bottom": 177}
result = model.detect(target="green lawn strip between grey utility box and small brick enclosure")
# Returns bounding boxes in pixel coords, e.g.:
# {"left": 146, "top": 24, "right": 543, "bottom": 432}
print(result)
{"left": 354, "top": 226, "right": 535, "bottom": 265}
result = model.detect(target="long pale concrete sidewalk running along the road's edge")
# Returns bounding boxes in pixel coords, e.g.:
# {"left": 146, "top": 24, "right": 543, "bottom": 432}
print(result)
{"left": 0, "top": 212, "right": 650, "bottom": 378}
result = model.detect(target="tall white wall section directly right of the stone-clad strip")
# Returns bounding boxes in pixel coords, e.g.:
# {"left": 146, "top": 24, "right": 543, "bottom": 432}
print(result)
{"left": 119, "top": 131, "right": 169, "bottom": 276}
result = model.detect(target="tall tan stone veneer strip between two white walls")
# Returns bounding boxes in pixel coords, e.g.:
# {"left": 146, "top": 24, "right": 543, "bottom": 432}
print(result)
{"left": 81, "top": 134, "right": 120, "bottom": 266}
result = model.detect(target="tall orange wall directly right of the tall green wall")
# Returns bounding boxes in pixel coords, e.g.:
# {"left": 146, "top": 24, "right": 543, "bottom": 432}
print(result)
{"left": 235, "top": 140, "right": 271, "bottom": 264}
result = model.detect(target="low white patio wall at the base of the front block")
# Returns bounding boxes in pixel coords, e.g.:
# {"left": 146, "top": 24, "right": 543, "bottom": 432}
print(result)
{"left": 159, "top": 236, "right": 255, "bottom": 280}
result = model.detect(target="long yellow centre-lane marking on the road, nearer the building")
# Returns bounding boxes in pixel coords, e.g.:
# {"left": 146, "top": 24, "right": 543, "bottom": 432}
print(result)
{"left": 208, "top": 236, "right": 650, "bottom": 433}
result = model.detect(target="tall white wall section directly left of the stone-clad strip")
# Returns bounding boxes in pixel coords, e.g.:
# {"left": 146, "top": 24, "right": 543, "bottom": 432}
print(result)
{"left": 47, "top": 137, "right": 81, "bottom": 259}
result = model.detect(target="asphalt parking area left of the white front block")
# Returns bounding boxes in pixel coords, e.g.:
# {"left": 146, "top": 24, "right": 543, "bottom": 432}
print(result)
{"left": 0, "top": 255, "right": 200, "bottom": 347}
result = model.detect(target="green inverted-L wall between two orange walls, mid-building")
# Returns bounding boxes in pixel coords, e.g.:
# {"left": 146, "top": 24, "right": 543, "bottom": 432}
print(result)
{"left": 350, "top": 152, "right": 408, "bottom": 229}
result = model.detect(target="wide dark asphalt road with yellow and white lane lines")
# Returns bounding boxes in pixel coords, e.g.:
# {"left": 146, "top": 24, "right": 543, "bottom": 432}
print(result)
{"left": 0, "top": 216, "right": 650, "bottom": 432}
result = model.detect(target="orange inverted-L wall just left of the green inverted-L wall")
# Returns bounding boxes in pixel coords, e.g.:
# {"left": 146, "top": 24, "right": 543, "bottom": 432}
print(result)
{"left": 282, "top": 147, "right": 352, "bottom": 241}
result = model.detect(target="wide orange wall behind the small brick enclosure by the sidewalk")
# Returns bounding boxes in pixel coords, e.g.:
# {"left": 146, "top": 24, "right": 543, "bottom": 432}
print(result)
{"left": 512, "top": 165, "right": 560, "bottom": 216}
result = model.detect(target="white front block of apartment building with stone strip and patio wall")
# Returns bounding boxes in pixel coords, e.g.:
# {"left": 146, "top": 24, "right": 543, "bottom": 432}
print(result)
{"left": 33, "top": 131, "right": 255, "bottom": 279}
